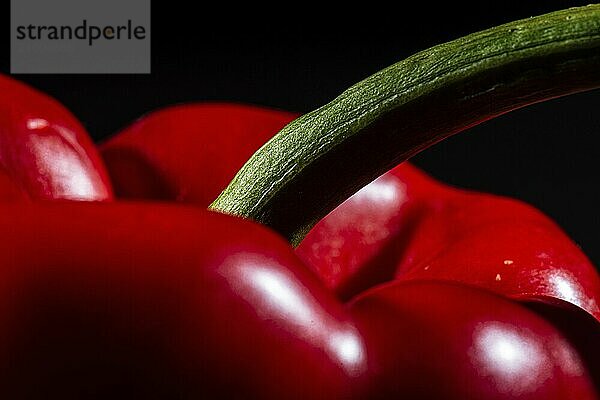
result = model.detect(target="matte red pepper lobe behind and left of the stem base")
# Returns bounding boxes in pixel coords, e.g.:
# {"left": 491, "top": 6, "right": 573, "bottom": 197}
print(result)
{"left": 101, "top": 103, "right": 297, "bottom": 207}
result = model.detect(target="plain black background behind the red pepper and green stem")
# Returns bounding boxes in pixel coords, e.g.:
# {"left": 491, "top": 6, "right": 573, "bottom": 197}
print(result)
{"left": 0, "top": 0, "right": 600, "bottom": 265}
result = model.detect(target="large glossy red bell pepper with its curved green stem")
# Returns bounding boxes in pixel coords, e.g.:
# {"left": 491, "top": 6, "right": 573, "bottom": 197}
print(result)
{"left": 0, "top": 7, "right": 600, "bottom": 399}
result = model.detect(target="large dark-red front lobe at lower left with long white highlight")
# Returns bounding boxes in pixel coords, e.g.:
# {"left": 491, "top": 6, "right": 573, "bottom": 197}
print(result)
{"left": 0, "top": 202, "right": 358, "bottom": 399}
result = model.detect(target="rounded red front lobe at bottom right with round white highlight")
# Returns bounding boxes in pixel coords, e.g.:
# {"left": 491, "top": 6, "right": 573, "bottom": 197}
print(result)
{"left": 350, "top": 281, "right": 596, "bottom": 400}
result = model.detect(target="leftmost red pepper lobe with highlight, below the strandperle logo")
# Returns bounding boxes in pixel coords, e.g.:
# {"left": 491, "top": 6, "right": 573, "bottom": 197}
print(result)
{"left": 0, "top": 74, "right": 112, "bottom": 201}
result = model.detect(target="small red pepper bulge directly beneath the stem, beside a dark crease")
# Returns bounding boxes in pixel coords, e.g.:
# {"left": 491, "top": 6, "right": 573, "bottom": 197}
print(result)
{"left": 296, "top": 163, "right": 441, "bottom": 299}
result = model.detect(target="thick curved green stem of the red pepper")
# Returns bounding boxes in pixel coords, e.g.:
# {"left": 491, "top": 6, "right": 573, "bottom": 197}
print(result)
{"left": 211, "top": 5, "right": 600, "bottom": 244}
